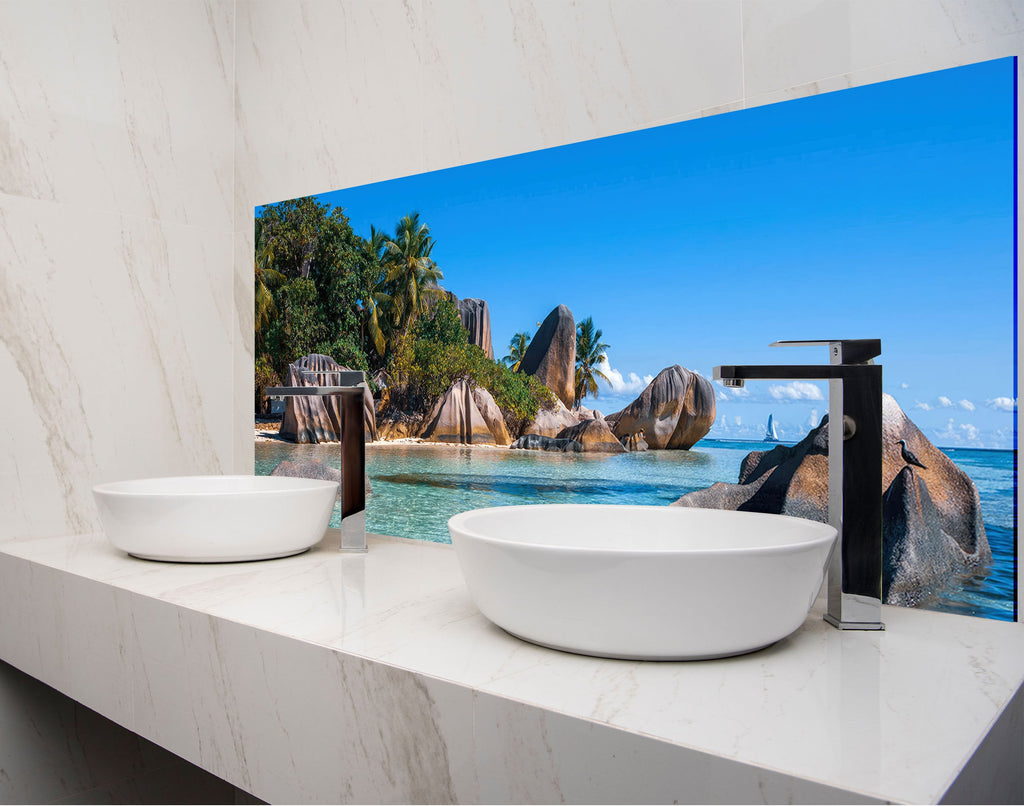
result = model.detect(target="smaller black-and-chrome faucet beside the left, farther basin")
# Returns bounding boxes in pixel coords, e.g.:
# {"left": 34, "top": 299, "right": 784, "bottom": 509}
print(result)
{"left": 263, "top": 370, "right": 367, "bottom": 552}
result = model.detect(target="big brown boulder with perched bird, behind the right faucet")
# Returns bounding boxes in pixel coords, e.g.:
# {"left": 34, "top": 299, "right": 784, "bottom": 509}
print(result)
{"left": 675, "top": 394, "right": 991, "bottom": 603}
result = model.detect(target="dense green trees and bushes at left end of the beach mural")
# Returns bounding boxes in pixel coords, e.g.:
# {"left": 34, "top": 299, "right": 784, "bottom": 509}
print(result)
{"left": 254, "top": 198, "right": 554, "bottom": 433}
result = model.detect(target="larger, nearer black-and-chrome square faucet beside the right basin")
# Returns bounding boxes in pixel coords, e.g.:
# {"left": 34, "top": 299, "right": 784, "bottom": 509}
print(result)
{"left": 714, "top": 339, "right": 885, "bottom": 630}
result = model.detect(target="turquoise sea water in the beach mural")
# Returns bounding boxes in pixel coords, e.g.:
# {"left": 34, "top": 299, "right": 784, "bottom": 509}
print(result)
{"left": 256, "top": 439, "right": 1015, "bottom": 621}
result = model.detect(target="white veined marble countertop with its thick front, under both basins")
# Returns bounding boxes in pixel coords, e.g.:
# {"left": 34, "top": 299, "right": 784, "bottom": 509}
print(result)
{"left": 0, "top": 535, "right": 1024, "bottom": 802}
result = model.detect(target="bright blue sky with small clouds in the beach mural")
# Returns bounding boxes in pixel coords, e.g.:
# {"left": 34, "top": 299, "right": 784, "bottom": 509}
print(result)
{"left": 307, "top": 58, "right": 1016, "bottom": 448}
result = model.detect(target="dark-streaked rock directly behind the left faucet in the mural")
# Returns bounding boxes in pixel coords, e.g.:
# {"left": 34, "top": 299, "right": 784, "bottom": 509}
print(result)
{"left": 280, "top": 353, "right": 377, "bottom": 444}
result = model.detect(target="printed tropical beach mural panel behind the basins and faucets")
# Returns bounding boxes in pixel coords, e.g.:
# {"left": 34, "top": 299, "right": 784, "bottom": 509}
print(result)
{"left": 254, "top": 58, "right": 1017, "bottom": 621}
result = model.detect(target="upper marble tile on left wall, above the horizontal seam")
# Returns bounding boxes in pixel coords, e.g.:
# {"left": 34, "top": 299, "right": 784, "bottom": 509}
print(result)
{"left": 0, "top": 0, "right": 233, "bottom": 230}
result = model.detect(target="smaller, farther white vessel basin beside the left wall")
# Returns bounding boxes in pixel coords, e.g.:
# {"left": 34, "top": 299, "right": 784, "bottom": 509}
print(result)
{"left": 92, "top": 476, "right": 338, "bottom": 562}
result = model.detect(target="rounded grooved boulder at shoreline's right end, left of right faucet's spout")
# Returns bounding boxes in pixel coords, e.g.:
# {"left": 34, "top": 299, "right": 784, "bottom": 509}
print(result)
{"left": 608, "top": 364, "right": 715, "bottom": 451}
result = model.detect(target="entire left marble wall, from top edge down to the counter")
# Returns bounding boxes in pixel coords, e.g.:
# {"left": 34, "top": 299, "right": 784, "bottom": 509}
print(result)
{"left": 0, "top": 0, "right": 238, "bottom": 540}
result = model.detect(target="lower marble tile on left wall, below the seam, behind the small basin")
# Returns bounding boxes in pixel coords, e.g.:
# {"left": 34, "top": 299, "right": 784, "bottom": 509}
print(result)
{"left": 0, "top": 196, "right": 236, "bottom": 539}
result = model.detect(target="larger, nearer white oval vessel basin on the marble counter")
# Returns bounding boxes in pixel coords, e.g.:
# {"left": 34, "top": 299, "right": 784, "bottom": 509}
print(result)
{"left": 449, "top": 504, "right": 837, "bottom": 661}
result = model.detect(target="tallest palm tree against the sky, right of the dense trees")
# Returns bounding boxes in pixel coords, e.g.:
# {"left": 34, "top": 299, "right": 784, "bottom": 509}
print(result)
{"left": 383, "top": 212, "right": 444, "bottom": 335}
